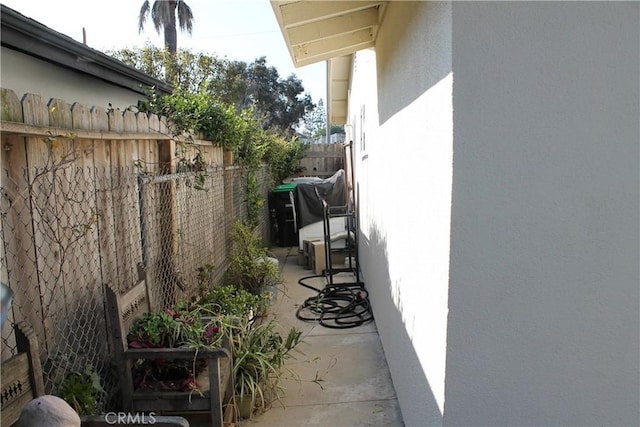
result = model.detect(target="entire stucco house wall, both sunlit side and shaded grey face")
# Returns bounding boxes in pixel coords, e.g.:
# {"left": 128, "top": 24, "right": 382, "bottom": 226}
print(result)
{"left": 349, "top": 2, "right": 640, "bottom": 426}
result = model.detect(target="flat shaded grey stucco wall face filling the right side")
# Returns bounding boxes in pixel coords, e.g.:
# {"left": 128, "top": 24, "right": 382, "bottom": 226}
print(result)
{"left": 444, "top": 2, "right": 640, "bottom": 426}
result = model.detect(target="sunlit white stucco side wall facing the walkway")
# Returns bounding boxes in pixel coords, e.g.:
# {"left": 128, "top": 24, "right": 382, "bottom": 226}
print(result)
{"left": 349, "top": 2, "right": 453, "bottom": 426}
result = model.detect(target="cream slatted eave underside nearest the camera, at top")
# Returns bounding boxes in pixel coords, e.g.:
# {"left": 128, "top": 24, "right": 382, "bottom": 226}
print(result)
{"left": 271, "top": 0, "right": 387, "bottom": 67}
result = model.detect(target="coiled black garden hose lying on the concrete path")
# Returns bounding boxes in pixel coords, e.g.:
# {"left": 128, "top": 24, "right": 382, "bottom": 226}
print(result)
{"left": 296, "top": 275, "right": 373, "bottom": 329}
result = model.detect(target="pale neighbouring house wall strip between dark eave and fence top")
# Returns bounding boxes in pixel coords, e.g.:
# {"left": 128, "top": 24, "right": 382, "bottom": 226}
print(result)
{"left": 0, "top": 47, "right": 145, "bottom": 110}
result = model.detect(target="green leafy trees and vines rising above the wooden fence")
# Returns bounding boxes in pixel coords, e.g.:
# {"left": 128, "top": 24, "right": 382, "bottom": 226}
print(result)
{"left": 111, "top": 46, "right": 315, "bottom": 224}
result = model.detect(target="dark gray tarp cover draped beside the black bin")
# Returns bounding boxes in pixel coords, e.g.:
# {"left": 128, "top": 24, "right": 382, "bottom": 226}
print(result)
{"left": 295, "top": 169, "right": 346, "bottom": 229}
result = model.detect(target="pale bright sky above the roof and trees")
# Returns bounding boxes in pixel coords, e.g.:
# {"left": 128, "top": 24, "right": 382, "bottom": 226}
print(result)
{"left": 0, "top": 0, "right": 326, "bottom": 104}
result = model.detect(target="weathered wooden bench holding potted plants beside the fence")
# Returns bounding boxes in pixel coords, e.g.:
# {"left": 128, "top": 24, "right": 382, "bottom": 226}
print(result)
{"left": 107, "top": 280, "right": 233, "bottom": 427}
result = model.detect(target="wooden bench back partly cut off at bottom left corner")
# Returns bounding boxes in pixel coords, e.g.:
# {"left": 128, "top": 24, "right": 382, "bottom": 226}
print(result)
{"left": 0, "top": 322, "right": 44, "bottom": 426}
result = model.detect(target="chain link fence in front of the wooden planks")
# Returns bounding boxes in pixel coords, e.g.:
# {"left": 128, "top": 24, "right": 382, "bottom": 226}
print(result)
{"left": 0, "top": 163, "right": 269, "bottom": 410}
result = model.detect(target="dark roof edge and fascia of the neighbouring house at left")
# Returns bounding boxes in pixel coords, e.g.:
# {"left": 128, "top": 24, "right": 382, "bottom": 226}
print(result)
{"left": 0, "top": 5, "right": 172, "bottom": 95}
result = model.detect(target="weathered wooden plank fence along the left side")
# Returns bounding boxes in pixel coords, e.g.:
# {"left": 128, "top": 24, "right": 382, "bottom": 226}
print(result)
{"left": 0, "top": 89, "right": 269, "bottom": 406}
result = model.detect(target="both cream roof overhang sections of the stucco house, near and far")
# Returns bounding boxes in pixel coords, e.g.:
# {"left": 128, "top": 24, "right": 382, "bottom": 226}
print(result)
{"left": 271, "top": 0, "right": 388, "bottom": 124}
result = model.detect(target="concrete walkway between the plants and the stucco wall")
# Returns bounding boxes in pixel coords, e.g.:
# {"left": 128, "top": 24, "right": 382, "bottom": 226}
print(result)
{"left": 241, "top": 247, "right": 403, "bottom": 427}
